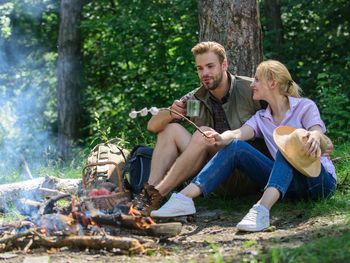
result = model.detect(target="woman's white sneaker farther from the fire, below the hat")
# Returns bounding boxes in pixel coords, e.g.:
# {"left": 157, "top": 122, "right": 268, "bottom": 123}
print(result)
{"left": 237, "top": 204, "right": 270, "bottom": 232}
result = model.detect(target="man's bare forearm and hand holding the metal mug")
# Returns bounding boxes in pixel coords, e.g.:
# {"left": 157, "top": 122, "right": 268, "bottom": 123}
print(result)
{"left": 147, "top": 100, "right": 186, "bottom": 133}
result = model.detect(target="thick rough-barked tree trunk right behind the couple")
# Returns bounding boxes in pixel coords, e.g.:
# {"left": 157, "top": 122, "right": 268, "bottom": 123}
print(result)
{"left": 198, "top": 0, "right": 262, "bottom": 76}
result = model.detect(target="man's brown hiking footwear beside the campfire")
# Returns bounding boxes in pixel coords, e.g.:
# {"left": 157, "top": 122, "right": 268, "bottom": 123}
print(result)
{"left": 132, "top": 183, "right": 163, "bottom": 216}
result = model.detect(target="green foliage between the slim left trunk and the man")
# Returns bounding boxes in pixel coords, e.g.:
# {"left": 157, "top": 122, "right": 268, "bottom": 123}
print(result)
{"left": 82, "top": 0, "right": 198, "bottom": 147}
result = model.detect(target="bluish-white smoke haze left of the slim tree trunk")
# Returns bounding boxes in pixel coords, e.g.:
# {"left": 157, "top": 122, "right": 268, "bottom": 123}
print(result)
{"left": 0, "top": 0, "right": 56, "bottom": 183}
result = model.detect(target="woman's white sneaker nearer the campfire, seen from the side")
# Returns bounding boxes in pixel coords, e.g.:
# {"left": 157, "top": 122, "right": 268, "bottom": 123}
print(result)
{"left": 151, "top": 193, "right": 196, "bottom": 217}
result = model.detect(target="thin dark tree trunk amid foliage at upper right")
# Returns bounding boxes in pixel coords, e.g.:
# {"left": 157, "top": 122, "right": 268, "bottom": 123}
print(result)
{"left": 265, "top": 0, "right": 283, "bottom": 47}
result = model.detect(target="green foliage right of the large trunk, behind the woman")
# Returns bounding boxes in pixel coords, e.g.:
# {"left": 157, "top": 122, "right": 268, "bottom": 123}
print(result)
{"left": 261, "top": 0, "right": 350, "bottom": 141}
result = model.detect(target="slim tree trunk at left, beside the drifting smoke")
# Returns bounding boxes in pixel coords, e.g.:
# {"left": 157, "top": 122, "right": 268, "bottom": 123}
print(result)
{"left": 57, "top": 0, "right": 84, "bottom": 159}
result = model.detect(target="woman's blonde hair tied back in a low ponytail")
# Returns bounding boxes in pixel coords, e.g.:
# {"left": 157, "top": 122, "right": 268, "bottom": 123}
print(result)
{"left": 256, "top": 60, "right": 302, "bottom": 98}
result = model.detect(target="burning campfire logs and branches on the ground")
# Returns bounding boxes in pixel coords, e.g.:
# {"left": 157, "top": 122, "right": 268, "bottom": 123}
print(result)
{"left": 0, "top": 178, "right": 182, "bottom": 253}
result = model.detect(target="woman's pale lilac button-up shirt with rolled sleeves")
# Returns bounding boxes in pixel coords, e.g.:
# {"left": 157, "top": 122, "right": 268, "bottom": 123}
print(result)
{"left": 245, "top": 97, "right": 336, "bottom": 178}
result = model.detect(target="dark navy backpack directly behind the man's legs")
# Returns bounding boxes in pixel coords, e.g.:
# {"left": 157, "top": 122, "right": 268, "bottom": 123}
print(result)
{"left": 123, "top": 145, "right": 153, "bottom": 195}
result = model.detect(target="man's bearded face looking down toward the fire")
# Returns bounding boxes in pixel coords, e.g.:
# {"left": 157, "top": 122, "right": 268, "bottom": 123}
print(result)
{"left": 196, "top": 52, "right": 227, "bottom": 90}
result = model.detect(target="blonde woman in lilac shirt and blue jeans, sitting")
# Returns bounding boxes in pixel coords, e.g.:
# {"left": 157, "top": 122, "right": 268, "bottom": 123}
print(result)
{"left": 151, "top": 60, "right": 336, "bottom": 231}
